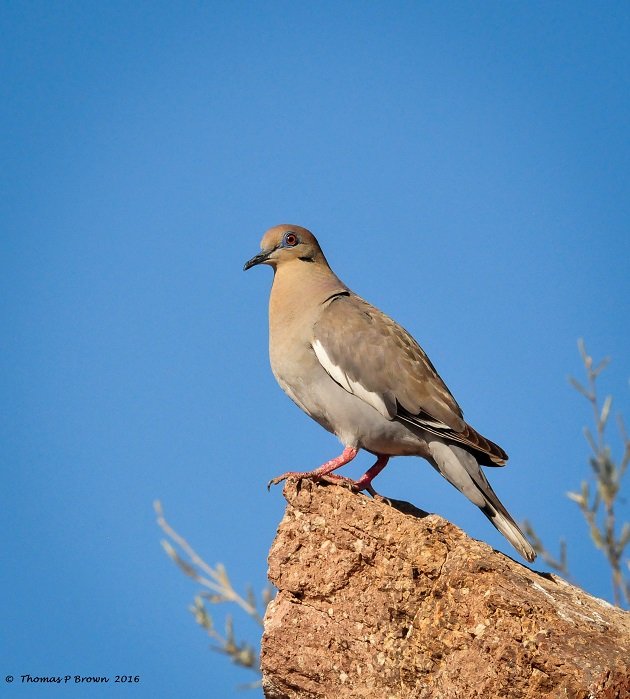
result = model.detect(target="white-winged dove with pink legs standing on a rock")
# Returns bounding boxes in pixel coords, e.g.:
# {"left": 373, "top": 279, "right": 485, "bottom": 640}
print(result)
{"left": 244, "top": 225, "right": 536, "bottom": 561}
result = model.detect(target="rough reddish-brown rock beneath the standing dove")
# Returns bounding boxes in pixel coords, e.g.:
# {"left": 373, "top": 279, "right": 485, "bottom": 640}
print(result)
{"left": 262, "top": 481, "right": 630, "bottom": 699}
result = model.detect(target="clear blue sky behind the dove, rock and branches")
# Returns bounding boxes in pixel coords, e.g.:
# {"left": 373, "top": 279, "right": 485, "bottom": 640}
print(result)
{"left": 0, "top": 2, "right": 630, "bottom": 698}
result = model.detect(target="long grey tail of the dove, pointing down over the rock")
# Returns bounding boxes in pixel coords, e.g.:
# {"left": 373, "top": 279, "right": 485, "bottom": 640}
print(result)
{"left": 429, "top": 439, "right": 536, "bottom": 562}
